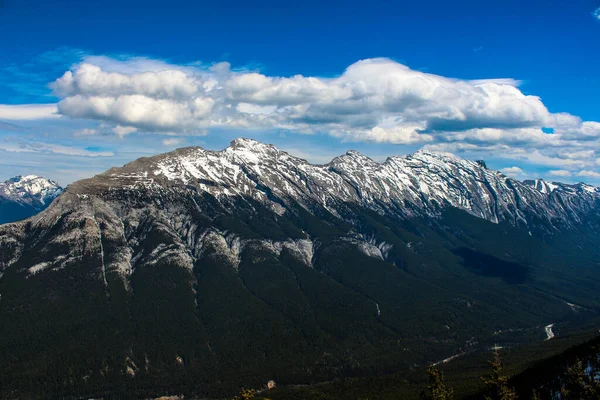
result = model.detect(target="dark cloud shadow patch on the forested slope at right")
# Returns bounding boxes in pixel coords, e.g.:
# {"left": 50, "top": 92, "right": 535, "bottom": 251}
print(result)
{"left": 452, "top": 247, "right": 532, "bottom": 285}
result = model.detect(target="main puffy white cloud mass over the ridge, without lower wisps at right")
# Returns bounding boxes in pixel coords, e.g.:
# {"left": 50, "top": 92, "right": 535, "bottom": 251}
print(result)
{"left": 52, "top": 57, "right": 564, "bottom": 138}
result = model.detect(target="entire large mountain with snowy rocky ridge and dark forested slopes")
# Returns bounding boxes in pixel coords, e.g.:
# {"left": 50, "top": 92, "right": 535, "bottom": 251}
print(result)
{"left": 0, "top": 139, "right": 600, "bottom": 397}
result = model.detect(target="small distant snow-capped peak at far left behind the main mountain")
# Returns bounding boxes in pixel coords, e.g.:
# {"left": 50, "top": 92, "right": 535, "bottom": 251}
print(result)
{"left": 0, "top": 175, "right": 63, "bottom": 224}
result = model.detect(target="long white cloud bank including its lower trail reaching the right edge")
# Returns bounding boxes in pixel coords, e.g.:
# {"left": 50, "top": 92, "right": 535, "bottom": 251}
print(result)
{"left": 43, "top": 57, "right": 600, "bottom": 180}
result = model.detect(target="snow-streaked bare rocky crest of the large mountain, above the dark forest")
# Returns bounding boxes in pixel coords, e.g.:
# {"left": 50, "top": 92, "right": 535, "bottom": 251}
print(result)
{"left": 76, "top": 139, "right": 600, "bottom": 225}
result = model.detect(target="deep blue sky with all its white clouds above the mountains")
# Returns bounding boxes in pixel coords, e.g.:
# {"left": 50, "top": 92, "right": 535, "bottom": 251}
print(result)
{"left": 0, "top": 0, "right": 600, "bottom": 185}
